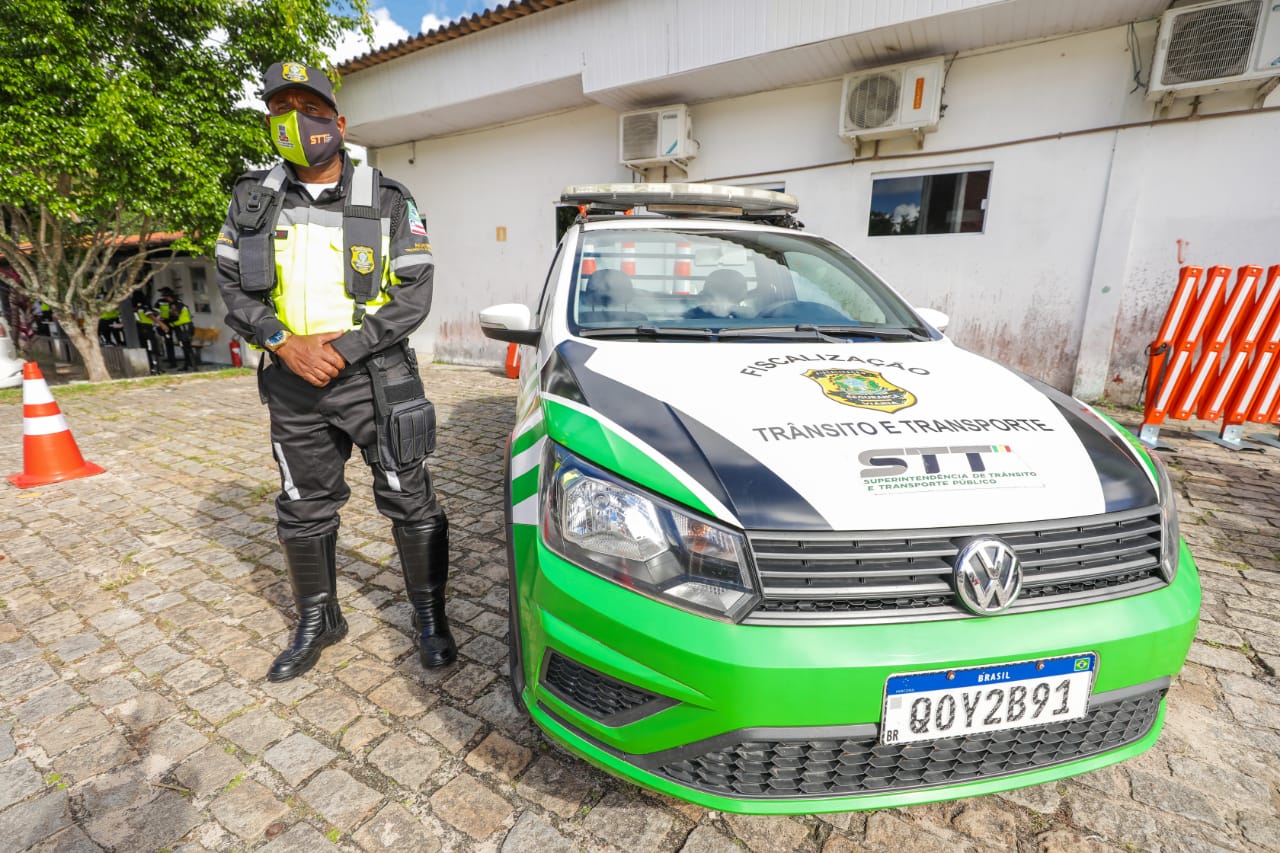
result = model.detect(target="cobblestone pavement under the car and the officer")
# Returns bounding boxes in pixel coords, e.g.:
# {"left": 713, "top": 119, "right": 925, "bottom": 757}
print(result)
{"left": 0, "top": 366, "right": 1280, "bottom": 853}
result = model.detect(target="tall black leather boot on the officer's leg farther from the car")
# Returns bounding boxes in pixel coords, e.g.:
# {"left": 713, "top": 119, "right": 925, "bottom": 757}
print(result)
{"left": 266, "top": 532, "right": 347, "bottom": 681}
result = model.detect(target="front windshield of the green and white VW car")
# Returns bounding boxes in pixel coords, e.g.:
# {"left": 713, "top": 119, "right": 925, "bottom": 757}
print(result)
{"left": 570, "top": 229, "right": 924, "bottom": 339}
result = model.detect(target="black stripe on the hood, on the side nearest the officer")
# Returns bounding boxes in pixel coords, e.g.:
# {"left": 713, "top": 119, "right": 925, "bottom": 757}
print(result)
{"left": 543, "top": 341, "right": 831, "bottom": 530}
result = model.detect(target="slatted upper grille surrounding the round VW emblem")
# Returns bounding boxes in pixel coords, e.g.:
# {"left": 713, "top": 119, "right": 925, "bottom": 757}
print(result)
{"left": 745, "top": 507, "right": 1167, "bottom": 625}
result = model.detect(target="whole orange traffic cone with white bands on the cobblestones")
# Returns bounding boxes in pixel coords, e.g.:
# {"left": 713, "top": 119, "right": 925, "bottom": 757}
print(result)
{"left": 9, "top": 361, "right": 104, "bottom": 489}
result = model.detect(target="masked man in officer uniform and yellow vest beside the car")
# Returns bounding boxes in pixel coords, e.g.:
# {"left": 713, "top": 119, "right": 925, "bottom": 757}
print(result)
{"left": 216, "top": 63, "right": 457, "bottom": 681}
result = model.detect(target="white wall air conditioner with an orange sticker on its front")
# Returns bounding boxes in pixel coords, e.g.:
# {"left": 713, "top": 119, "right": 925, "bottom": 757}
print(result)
{"left": 840, "top": 56, "right": 946, "bottom": 142}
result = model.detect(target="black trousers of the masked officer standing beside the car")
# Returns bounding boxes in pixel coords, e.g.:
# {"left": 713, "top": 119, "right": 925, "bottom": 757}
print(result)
{"left": 260, "top": 362, "right": 444, "bottom": 542}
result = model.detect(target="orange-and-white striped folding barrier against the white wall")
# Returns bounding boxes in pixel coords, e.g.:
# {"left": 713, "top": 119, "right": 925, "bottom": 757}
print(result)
{"left": 1139, "top": 265, "right": 1280, "bottom": 450}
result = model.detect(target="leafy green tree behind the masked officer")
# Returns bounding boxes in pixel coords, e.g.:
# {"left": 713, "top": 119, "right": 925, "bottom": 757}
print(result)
{"left": 0, "top": 0, "right": 371, "bottom": 379}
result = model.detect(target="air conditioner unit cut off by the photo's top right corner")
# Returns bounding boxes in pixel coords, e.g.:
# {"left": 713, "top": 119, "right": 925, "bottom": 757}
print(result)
{"left": 1147, "top": 0, "right": 1280, "bottom": 100}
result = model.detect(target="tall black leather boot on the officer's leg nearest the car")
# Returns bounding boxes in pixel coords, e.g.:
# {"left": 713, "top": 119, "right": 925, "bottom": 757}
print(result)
{"left": 393, "top": 512, "right": 458, "bottom": 669}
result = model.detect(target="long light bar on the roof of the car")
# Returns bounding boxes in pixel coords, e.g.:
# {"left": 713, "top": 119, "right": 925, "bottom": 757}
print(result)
{"left": 561, "top": 183, "right": 800, "bottom": 214}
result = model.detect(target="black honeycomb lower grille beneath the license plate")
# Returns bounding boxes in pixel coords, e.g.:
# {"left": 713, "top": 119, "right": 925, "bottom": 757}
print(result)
{"left": 655, "top": 680, "right": 1167, "bottom": 799}
